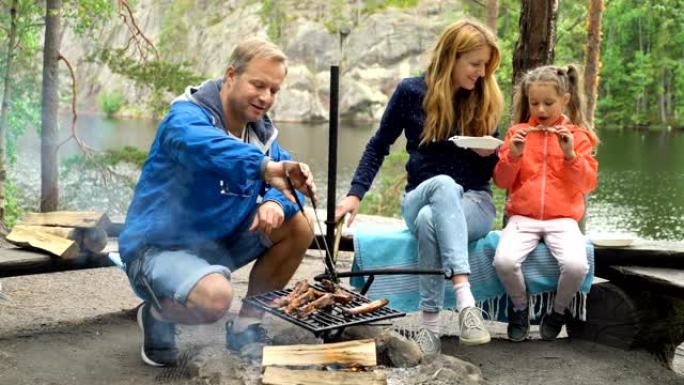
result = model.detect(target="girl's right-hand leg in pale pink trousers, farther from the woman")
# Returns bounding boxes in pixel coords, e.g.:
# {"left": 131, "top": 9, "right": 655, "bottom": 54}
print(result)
{"left": 544, "top": 218, "right": 589, "bottom": 314}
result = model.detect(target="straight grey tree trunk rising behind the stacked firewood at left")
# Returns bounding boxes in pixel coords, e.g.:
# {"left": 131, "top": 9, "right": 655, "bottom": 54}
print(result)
{"left": 40, "top": 0, "right": 62, "bottom": 212}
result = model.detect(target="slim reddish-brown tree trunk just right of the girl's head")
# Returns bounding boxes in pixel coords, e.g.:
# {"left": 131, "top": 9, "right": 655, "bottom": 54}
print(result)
{"left": 584, "top": 0, "right": 604, "bottom": 126}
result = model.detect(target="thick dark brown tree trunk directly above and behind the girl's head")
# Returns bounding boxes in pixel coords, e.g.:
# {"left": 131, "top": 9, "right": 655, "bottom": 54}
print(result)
{"left": 513, "top": 0, "right": 558, "bottom": 84}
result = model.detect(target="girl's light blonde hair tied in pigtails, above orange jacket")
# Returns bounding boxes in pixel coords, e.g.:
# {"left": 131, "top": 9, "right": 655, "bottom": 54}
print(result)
{"left": 512, "top": 64, "right": 598, "bottom": 146}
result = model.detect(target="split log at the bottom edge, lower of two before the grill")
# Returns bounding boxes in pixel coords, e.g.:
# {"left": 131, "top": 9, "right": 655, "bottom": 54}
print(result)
{"left": 261, "top": 367, "right": 387, "bottom": 385}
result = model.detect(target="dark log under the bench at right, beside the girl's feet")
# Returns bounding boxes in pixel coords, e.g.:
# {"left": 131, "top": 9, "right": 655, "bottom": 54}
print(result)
{"left": 568, "top": 281, "right": 684, "bottom": 367}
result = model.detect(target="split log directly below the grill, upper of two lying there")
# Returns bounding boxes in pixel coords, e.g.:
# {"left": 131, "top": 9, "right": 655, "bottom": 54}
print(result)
{"left": 261, "top": 340, "right": 377, "bottom": 367}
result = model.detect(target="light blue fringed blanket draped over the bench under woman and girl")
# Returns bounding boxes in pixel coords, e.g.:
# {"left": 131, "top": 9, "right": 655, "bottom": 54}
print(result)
{"left": 351, "top": 226, "right": 594, "bottom": 321}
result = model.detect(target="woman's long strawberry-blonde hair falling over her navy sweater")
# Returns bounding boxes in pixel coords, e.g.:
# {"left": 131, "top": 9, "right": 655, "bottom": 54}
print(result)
{"left": 420, "top": 20, "right": 503, "bottom": 144}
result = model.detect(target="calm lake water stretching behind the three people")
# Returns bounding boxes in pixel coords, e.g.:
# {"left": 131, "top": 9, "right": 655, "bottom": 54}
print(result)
{"left": 20, "top": 116, "right": 684, "bottom": 240}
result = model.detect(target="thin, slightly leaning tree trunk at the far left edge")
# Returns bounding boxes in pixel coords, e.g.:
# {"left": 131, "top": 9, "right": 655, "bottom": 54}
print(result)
{"left": 0, "top": 0, "right": 17, "bottom": 223}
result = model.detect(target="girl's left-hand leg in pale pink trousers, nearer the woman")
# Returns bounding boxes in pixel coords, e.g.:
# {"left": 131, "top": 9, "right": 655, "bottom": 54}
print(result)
{"left": 494, "top": 215, "right": 543, "bottom": 310}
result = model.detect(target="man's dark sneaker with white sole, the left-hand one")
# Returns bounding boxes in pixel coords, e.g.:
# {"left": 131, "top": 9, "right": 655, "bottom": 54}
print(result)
{"left": 138, "top": 302, "right": 178, "bottom": 367}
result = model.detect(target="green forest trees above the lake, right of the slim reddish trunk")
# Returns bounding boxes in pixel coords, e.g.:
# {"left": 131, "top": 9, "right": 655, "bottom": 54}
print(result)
{"left": 596, "top": 0, "right": 684, "bottom": 127}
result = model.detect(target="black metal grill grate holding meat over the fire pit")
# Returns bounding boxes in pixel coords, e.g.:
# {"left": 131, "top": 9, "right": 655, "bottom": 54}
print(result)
{"left": 244, "top": 283, "right": 406, "bottom": 336}
